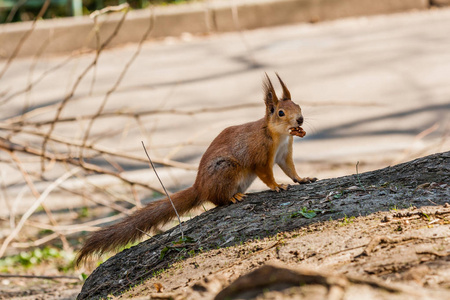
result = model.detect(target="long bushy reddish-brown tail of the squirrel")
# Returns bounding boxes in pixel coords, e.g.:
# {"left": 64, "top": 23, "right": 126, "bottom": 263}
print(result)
{"left": 76, "top": 187, "right": 200, "bottom": 265}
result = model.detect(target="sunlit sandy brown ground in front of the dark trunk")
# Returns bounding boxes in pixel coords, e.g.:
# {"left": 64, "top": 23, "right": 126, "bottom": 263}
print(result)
{"left": 121, "top": 206, "right": 450, "bottom": 299}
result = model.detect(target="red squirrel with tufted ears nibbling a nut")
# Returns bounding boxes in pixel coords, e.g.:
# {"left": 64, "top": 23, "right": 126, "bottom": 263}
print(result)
{"left": 76, "top": 74, "right": 317, "bottom": 265}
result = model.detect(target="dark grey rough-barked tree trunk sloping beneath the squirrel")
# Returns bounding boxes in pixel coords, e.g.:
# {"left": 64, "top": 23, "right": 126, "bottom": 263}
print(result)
{"left": 78, "top": 152, "right": 450, "bottom": 299}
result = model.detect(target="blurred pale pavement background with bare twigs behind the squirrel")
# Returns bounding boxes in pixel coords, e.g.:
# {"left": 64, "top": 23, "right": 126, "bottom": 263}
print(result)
{"left": 0, "top": 0, "right": 450, "bottom": 293}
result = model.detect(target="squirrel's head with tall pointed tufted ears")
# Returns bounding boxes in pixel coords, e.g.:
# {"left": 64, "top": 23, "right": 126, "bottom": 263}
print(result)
{"left": 263, "top": 73, "right": 303, "bottom": 135}
